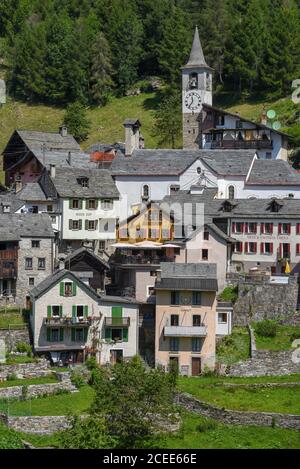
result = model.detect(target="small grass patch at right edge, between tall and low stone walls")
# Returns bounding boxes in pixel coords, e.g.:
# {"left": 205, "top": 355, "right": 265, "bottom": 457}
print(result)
{"left": 252, "top": 323, "right": 300, "bottom": 350}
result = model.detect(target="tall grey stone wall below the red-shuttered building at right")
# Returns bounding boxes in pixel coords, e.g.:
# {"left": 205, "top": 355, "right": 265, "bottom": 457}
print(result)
{"left": 233, "top": 276, "right": 300, "bottom": 326}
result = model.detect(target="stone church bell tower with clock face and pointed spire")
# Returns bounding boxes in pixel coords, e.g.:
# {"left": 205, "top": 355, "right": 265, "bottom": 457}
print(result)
{"left": 182, "top": 26, "right": 212, "bottom": 149}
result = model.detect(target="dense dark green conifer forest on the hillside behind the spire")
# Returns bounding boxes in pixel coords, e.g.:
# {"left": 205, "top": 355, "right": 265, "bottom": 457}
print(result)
{"left": 0, "top": 0, "right": 300, "bottom": 104}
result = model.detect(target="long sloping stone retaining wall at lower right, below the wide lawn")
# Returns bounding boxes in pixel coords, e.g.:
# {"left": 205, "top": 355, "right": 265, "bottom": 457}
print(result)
{"left": 175, "top": 393, "right": 300, "bottom": 430}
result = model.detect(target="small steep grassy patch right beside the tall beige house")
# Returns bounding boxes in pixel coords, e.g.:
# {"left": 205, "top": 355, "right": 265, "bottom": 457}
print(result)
{"left": 217, "top": 327, "right": 250, "bottom": 365}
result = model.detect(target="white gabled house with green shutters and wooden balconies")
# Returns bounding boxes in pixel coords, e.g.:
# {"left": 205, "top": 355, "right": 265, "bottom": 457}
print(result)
{"left": 30, "top": 270, "right": 139, "bottom": 364}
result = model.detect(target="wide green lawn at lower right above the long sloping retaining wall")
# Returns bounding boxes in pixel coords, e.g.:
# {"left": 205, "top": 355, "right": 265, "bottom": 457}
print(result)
{"left": 178, "top": 375, "right": 300, "bottom": 414}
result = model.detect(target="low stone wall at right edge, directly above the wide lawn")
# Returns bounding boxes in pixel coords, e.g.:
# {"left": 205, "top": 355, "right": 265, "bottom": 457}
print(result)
{"left": 228, "top": 349, "right": 300, "bottom": 377}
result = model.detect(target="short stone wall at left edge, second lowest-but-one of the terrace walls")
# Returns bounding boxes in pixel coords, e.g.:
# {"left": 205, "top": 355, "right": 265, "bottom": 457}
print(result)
{"left": 0, "top": 359, "right": 51, "bottom": 380}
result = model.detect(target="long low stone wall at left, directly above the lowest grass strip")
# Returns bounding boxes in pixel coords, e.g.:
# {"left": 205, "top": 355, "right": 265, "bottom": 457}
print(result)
{"left": 0, "top": 380, "right": 77, "bottom": 399}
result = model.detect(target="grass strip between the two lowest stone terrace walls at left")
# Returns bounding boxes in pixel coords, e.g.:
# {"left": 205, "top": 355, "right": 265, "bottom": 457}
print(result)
{"left": 0, "top": 386, "right": 94, "bottom": 416}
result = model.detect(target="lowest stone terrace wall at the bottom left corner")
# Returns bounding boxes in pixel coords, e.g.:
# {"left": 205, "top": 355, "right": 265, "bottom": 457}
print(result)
{"left": 0, "top": 414, "right": 70, "bottom": 435}
